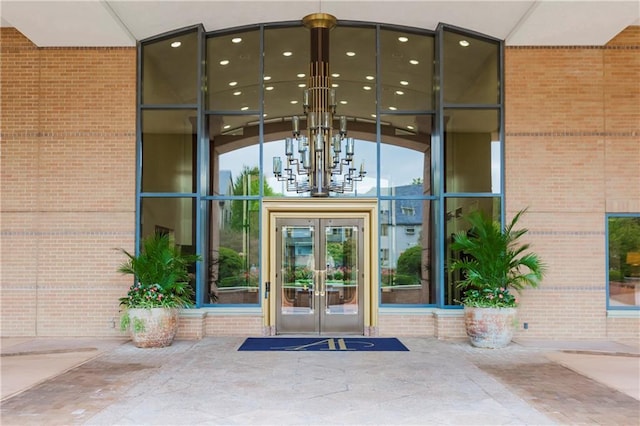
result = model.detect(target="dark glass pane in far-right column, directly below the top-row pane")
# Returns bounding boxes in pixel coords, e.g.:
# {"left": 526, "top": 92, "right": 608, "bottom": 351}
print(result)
{"left": 444, "top": 109, "right": 501, "bottom": 193}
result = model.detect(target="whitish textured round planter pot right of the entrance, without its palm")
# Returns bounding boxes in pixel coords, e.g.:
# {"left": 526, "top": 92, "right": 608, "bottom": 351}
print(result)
{"left": 464, "top": 306, "right": 517, "bottom": 349}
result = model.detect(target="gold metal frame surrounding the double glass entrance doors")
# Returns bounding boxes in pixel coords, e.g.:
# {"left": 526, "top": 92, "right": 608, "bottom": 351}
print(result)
{"left": 261, "top": 198, "right": 378, "bottom": 335}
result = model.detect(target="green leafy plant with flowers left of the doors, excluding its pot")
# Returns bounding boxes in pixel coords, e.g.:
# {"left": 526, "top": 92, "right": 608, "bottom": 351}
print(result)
{"left": 118, "top": 233, "right": 200, "bottom": 328}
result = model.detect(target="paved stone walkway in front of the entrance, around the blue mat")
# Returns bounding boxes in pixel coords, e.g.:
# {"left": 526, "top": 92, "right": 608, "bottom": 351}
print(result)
{"left": 0, "top": 337, "right": 640, "bottom": 426}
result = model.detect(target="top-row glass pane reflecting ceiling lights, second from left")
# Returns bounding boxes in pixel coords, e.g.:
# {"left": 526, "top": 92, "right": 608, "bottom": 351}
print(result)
{"left": 207, "top": 30, "right": 260, "bottom": 111}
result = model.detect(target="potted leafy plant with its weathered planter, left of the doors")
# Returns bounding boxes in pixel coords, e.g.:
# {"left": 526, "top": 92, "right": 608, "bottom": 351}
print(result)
{"left": 118, "top": 233, "right": 200, "bottom": 348}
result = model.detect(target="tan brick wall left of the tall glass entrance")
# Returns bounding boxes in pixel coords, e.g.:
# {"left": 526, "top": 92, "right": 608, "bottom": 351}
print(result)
{"left": 0, "top": 28, "right": 136, "bottom": 337}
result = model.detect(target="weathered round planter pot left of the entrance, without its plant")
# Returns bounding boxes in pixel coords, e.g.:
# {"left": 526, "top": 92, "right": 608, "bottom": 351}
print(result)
{"left": 128, "top": 308, "right": 178, "bottom": 348}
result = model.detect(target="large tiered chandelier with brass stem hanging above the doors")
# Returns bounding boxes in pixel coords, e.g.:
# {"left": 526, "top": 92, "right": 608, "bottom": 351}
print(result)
{"left": 273, "top": 13, "right": 366, "bottom": 197}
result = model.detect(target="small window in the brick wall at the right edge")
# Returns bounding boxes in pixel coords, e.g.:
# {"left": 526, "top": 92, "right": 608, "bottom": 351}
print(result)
{"left": 607, "top": 215, "right": 640, "bottom": 309}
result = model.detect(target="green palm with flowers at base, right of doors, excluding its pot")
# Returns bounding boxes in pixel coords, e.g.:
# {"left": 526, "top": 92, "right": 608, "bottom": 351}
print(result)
{"left": 451, "top": 209, "right": 546, "bottom": 307}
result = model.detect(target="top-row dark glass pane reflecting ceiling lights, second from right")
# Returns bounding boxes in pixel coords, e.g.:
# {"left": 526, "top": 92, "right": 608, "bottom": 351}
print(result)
{"left": 380, "top": 30, "right": 434, "bottom": 111}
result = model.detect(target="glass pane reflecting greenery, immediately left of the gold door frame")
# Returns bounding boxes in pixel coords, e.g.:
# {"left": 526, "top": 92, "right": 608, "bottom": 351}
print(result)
{"left": 210, "top": 200, "right": 260, "bottom": 305}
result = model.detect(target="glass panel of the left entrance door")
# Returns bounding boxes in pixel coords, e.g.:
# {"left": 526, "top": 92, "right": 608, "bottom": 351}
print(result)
{"left": 279, "top": 226, "right": 316, "bottom": 315}
